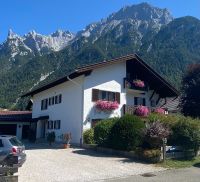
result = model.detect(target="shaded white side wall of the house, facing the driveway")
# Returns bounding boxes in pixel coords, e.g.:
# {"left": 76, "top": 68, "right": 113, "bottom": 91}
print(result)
{"left": 32, "top": 76, "right": 83, "bottom": 143}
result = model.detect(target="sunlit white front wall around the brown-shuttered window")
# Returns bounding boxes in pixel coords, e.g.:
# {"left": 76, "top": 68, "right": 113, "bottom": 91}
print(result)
{"left": 83, "top": 62, "right": 126, "bottom": 130}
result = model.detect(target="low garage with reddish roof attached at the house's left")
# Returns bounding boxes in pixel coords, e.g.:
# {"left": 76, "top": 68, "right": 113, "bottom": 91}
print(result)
{"left": 0, "top": 111, "right": 32, "bottom": 139}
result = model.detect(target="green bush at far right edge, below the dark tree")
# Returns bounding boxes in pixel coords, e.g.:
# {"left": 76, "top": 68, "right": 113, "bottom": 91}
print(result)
{"left": 171, "top": 118, "right": 200, "bottom": 153}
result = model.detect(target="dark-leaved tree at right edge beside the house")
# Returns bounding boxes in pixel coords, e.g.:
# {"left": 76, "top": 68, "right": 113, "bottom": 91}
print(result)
{"left": 181, "top": 64, "right": 200, "bottom": 117}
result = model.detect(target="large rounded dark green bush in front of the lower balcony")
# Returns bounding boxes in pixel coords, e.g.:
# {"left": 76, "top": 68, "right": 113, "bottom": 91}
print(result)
{"left": 109, "top": 115, "right": 144, "bottom": 150}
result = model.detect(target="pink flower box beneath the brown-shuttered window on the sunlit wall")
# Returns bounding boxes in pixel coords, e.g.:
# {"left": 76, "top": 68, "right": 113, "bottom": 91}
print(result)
{"left": 96, "top": 100, "right": 119, "bottom": 112}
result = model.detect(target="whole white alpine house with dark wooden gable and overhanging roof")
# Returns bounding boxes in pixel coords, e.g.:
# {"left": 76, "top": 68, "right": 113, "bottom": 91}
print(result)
{"left": 23, "top": 54, "right": 178, "bottom": 143}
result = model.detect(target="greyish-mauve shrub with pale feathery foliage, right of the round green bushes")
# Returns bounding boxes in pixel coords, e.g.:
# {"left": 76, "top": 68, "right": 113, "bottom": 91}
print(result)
{"left": 143, "top": 121, "right": 171, "bottom": 148}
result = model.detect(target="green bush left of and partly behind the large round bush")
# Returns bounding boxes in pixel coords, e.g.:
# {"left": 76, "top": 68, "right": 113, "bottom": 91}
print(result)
{"left": 94, "top": 118, "right": 118, "bottom": 146}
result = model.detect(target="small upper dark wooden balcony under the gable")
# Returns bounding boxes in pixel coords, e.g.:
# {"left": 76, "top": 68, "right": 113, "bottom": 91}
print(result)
{"left": 124, "top": 78, "right": 149, "bottom": 93}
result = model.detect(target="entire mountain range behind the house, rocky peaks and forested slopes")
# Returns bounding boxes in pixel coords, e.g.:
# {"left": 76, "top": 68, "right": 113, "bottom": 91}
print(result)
{"left": 0, "top": 3, "right": 200, "bottom": 109}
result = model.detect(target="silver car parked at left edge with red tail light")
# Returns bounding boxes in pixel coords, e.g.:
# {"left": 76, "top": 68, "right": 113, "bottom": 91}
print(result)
{"left": 0, "top": 135, "right": 26, "bottom": 175}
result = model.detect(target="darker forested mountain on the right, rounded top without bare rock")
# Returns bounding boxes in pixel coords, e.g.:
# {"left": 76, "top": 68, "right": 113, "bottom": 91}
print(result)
{"left": 140, "top": 16, "right": 200, "bottom": 84}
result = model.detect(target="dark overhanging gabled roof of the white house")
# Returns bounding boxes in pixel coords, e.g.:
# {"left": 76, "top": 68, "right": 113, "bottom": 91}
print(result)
{"left": 22, "top": 54, "right": 179, "bottom": 97}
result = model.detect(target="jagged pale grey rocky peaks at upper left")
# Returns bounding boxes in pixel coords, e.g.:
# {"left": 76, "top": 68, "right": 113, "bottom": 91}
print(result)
{"left": 0, "top": 29, "right": 75, "bottom": 59}
